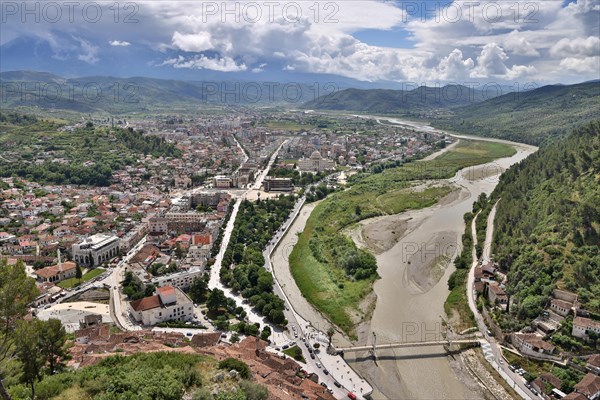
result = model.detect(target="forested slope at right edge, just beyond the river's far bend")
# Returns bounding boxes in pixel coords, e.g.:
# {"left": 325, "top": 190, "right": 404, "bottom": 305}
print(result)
{"left": 432, "top": 81, "right": 600, "bottom": 145}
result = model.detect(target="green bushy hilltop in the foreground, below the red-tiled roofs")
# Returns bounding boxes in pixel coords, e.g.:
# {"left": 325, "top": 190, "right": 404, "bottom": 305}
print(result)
{"left": 9, "top": 352, "right": 268, "bottom": 400}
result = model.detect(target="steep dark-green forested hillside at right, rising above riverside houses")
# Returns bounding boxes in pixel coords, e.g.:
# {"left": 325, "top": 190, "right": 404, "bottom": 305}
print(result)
{"left": 487, "top": 121, "right": 600, "bottom": 320}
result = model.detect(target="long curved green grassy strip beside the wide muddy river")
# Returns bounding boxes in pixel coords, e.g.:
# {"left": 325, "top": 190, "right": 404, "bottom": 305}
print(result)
{"left": 290, "top": 141, "right": 515, "bottom": 337}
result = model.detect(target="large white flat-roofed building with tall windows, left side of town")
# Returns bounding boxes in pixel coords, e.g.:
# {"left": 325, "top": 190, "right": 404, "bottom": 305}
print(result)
{"left": 71, "top": 233, "right": 120, "bottom": 267}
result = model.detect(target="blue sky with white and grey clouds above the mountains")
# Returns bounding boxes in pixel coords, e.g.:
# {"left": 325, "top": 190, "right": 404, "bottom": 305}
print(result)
{"left": 0, "top": 0, "right": 600, "bottom": 85}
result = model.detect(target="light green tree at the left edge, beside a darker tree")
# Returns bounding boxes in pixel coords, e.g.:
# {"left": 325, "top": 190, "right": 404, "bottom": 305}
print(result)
{"left": 0, "top": 260, "right": 38, "bottom": 400}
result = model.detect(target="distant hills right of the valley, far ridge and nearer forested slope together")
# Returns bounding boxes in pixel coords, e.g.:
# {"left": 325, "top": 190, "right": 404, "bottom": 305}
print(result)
{"left": 304, "top": 80, "right": 600, "bottom": 144}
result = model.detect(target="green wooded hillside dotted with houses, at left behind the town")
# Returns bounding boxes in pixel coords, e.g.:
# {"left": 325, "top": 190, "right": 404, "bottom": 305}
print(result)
{"left": 0, "top": 113, "right": 181, "bottom": 186}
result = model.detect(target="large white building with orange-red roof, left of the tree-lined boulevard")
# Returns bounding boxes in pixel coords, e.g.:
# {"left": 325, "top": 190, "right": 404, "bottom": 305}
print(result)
{"left": 129, "top": 286, "right": 194, "bottom": 325}
